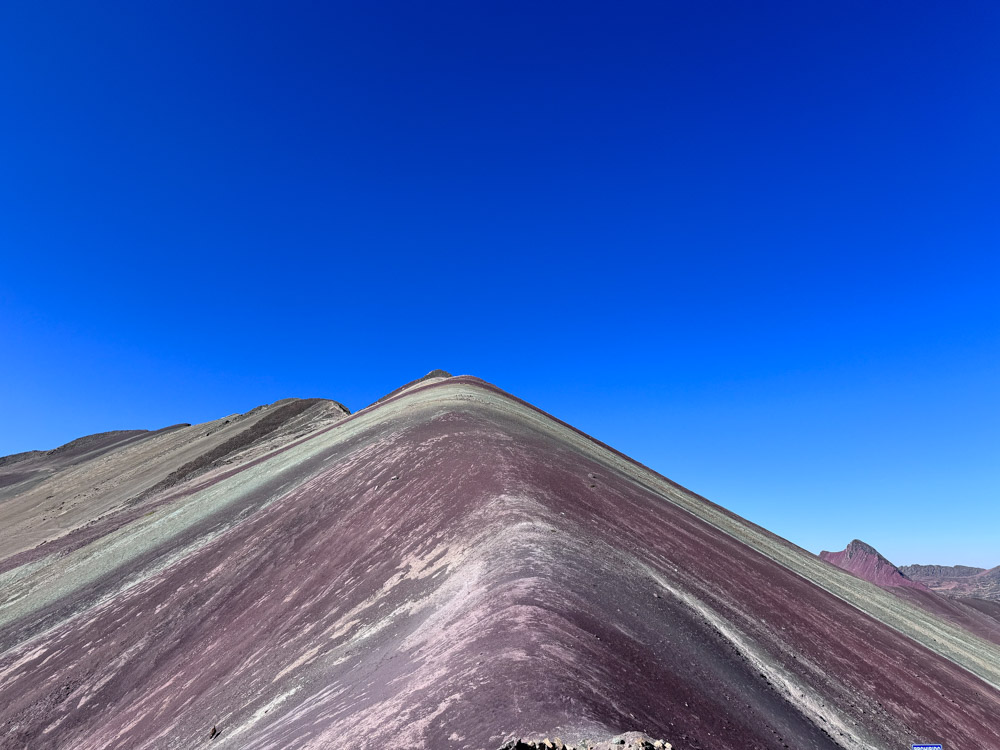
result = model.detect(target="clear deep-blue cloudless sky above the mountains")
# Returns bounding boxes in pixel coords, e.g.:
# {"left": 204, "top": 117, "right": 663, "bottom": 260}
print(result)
{"left": 0, "top": 0, "right": 1000, "bottom": 566}
